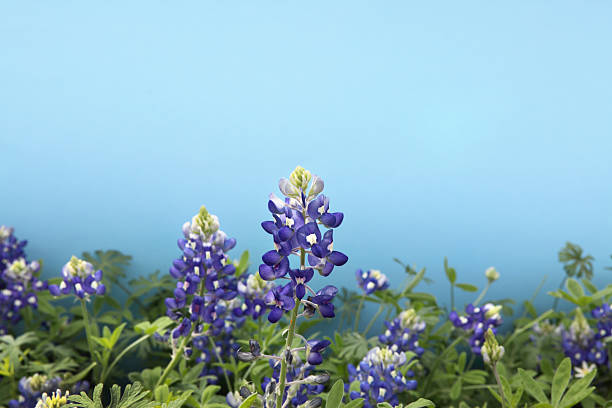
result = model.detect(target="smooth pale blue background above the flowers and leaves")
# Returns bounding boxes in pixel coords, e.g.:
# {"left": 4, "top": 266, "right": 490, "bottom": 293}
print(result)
{"left": 0, "top": 1, "right": 612, "bottom": 318}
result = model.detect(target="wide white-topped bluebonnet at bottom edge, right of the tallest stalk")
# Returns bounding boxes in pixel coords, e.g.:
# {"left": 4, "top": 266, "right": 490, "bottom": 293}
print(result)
{"left": 345, "top": 347, "right": 417, "bottom": 408}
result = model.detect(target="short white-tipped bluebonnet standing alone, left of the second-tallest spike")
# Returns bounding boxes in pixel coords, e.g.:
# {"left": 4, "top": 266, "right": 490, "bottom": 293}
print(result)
{"left": 49, "top": 256, "right": 106, "bottom": 299}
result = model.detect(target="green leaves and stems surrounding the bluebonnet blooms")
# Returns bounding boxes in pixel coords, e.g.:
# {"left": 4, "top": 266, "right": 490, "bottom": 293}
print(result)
{"left": 0, "top": 243, "right": 612, "bottom": 408}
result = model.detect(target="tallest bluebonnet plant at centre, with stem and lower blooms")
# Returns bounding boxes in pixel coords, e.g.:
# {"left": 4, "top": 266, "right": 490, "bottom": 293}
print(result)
{"left": 249, "top": 166, "right": 348, "bottom": 408}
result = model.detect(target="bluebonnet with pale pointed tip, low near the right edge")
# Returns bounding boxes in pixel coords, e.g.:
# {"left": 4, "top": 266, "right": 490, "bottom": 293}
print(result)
{"left": 561, "top": 308, "right": 608, "bottom": 368}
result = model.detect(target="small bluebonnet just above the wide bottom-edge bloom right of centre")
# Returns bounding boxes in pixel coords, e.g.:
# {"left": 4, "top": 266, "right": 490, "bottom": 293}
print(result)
{"left": 378, "top": 309, "right": 425, "bottom": 356}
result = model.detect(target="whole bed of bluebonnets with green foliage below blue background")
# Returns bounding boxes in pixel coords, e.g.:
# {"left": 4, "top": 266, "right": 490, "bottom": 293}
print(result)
{"left": 0, "top": 167, "right": 612, "bottom": 408}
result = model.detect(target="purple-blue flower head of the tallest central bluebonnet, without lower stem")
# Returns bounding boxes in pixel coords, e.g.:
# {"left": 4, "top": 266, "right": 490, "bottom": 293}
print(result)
{"left": 259, "top": 167, "right": 348, "bottom": 322}
